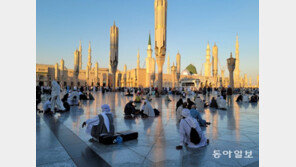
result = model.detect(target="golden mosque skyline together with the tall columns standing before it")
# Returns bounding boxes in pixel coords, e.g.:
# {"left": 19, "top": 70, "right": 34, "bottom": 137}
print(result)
{"left": 36, "top": 0, "right": 259, "bottom": 89}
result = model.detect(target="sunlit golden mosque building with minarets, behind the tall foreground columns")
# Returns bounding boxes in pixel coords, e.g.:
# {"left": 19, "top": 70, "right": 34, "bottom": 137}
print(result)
{"left": 36, "top": 34, "right": 259, "bottom": 88}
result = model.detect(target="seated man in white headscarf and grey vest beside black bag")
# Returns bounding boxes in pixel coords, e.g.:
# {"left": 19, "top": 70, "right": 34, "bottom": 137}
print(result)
{"left": 82, "top": 104, "right": 114, "bottom": 141}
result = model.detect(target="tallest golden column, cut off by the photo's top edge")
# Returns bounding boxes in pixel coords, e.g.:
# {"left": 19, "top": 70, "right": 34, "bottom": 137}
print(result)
{"left": 154, "top": 0, "right": 167, "bottom": 91}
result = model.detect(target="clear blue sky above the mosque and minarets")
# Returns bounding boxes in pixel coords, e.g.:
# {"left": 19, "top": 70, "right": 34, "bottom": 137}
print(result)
{"left": 36, "top": 0, "right": 259, "bottom": 83}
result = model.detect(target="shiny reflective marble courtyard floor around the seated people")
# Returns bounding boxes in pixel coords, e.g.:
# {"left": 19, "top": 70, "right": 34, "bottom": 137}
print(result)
{"left": 36, "top": 92, "right": 259, "bottom": 167}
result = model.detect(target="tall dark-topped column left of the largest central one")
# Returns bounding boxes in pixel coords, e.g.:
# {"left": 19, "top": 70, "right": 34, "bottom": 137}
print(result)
{"left": 110, "top": 21, "right": 119, "bottom": 90}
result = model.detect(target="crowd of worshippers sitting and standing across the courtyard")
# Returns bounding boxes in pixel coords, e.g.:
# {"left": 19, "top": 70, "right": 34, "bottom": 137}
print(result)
{"left": 36, "top": 83, "right": 259, "bottom": 149}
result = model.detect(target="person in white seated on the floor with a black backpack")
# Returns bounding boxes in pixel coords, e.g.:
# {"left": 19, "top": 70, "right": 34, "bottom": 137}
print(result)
{"left": 176, "top": 109, "right": 209, "bottom": 149}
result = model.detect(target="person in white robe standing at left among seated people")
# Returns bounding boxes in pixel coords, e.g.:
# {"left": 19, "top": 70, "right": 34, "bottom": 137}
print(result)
{"left": 50, "top": 80, "right": 65, "bottom": 112}
